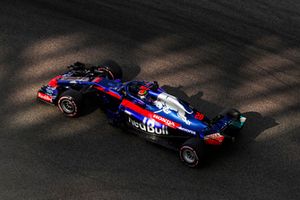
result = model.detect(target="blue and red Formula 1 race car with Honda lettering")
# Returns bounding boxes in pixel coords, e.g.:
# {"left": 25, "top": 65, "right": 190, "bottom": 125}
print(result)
{"left": 37, "top": 61, "right": 246, "bottom": 167}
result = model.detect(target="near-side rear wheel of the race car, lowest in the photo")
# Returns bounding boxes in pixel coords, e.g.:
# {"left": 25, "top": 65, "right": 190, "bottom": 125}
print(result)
{"left": 179, "top": 138, "right": 204, "bottom": 168}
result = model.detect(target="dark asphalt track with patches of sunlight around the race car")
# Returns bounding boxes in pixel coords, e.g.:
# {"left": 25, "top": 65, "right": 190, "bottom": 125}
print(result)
{"left": 0, "top": 0, "right": 300, "bottom": 200}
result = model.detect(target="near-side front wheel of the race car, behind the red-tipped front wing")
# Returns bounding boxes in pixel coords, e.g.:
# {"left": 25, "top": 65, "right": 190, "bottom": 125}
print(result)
{"left": 57, "top": 89, "right": 82, "bottom": 117}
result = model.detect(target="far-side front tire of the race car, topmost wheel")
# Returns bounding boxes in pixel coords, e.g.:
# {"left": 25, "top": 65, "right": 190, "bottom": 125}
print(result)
{"left": 98, "top": 60, "right": 123, "bottom": 80}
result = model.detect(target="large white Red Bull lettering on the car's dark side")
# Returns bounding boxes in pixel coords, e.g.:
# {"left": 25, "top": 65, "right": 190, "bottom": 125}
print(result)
{"left": 128, "top": 117, "right": 168, "bottom": 135}
